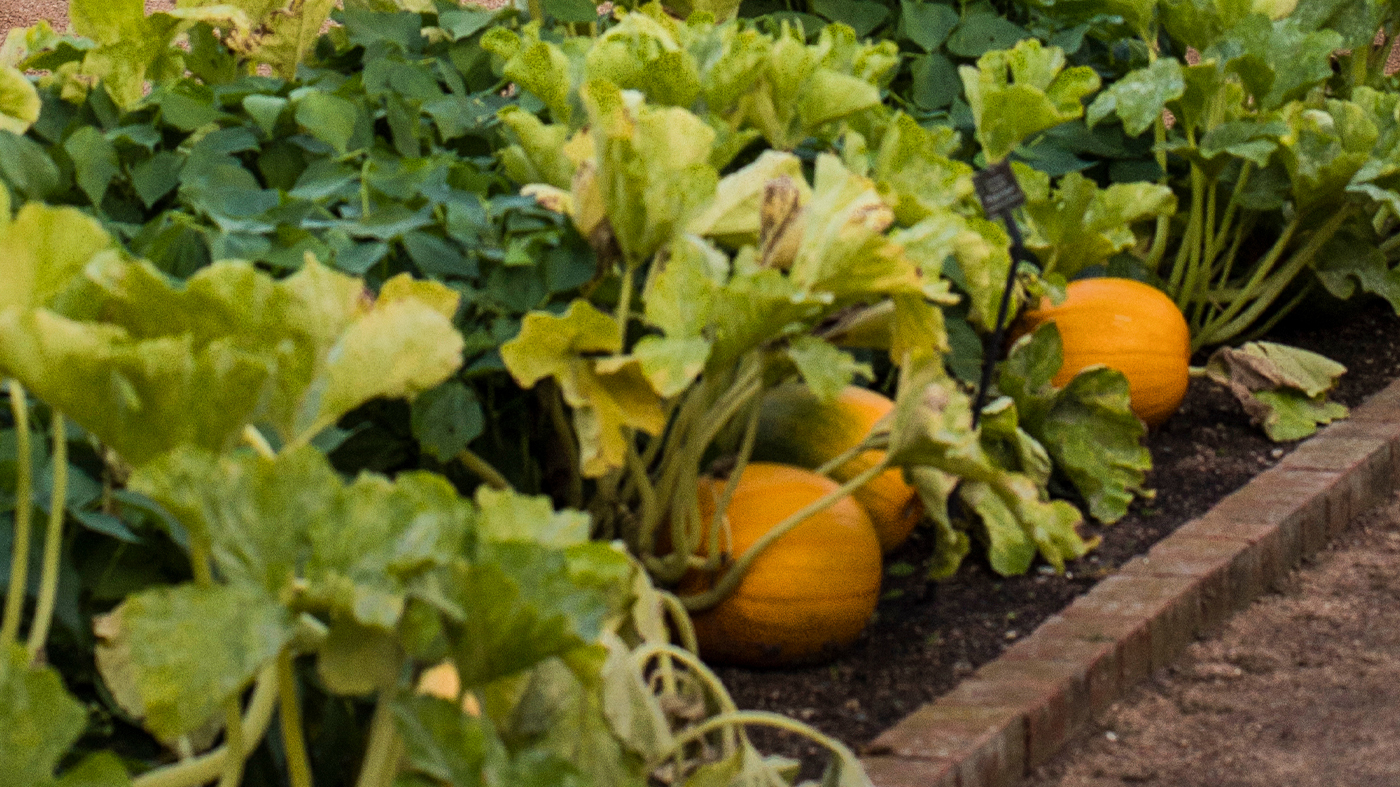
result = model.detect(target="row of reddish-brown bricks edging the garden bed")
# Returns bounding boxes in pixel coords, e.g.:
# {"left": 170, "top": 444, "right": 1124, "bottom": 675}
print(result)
{"left": 861, "top": 379, "right": 1400, "bottom": 787}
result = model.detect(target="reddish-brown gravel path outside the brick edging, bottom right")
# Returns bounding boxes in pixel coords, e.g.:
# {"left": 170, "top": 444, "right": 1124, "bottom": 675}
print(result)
{"left": 1023, "top": 492, "right": 1400, "bottom": 787}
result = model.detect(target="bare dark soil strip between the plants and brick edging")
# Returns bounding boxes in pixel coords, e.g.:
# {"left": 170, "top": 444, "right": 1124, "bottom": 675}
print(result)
{"left": 718, "top": 298, "right": 1400, "bottom": 776}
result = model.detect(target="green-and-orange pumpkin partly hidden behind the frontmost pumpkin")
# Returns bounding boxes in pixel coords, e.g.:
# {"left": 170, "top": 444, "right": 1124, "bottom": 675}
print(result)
{"left": 753, "top": 384, "right": 924, "bottom": 552}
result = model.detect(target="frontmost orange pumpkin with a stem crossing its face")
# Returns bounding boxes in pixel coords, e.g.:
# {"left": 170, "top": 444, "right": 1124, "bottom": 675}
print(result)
{"left": 680, "top": 462, "right": 882, "bottom": 667}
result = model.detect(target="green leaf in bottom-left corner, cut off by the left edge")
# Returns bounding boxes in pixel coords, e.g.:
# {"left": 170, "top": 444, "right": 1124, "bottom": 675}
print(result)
{"left": 0, "top": 646, "right": 87, "bottom": 787}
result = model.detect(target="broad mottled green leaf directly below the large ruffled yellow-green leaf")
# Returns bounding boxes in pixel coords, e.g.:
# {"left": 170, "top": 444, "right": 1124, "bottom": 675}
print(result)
{"left": 130, "top": 447, "right": 475, "bottom": 629}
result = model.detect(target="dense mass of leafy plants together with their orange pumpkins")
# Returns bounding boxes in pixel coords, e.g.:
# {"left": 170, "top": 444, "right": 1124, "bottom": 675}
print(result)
{"left": 0, "top": 0, "right": 1400, "bottom": 787}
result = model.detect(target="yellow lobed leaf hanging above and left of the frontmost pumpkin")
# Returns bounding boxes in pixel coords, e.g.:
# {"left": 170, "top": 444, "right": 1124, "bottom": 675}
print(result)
{"left": 501, "top": 300, "right": 665, "bottom": 478}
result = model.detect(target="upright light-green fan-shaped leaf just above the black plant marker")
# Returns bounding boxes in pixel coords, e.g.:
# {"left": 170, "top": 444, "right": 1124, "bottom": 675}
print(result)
{"left": 958, "top": 38, "right": 1099, "bottom": 162}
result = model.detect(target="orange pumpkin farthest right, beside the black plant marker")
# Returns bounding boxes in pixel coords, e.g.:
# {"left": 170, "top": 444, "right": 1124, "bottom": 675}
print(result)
{"left": 1019, "top": 277, "right": 1191, "bottom": 426}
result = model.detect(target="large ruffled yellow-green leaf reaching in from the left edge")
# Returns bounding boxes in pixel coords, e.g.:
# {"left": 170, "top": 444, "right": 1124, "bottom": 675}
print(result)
{"left": 0, "top": 247, "right": 463, "bottom": 464}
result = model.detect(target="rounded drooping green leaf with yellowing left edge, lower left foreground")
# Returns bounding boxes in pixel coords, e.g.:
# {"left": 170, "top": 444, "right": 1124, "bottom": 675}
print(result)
{"left": 115, "top": 584, "right": 294, "bottom": 739}
